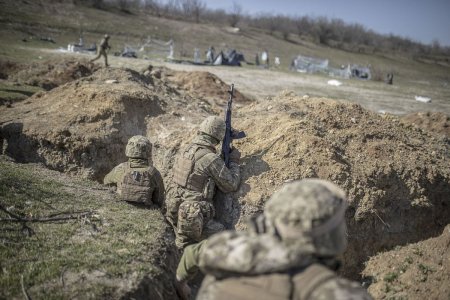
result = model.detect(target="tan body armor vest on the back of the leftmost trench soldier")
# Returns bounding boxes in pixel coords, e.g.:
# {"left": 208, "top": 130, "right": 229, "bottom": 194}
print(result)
{"left": 118, "top": 163, "right": 156, "bottom": 204}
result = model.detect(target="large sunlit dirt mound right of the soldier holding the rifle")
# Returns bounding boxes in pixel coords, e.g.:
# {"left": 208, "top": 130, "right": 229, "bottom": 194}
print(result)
{"left": 229, "top": 93, "right": 450, "bottom": 277}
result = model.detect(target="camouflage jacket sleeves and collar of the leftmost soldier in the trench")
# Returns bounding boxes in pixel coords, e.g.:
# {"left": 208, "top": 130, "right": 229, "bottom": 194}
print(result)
{"left": 103, "top": 158, "right": 165, "bottom": 207}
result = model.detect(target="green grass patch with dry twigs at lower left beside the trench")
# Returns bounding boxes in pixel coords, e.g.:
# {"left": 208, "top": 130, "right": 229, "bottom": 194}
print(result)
{"left": 0, "top": 159, "right": 173, "bottom": 299}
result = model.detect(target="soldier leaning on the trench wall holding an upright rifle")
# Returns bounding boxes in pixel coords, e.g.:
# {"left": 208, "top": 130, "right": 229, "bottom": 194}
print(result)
{"left": 166, "top": 116, "right": 241, "bottom": 249}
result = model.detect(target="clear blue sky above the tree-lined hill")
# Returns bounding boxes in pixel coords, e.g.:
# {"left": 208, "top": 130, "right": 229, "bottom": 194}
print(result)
{"left": 203, "top": 0, "right": 450, "bottom": 46}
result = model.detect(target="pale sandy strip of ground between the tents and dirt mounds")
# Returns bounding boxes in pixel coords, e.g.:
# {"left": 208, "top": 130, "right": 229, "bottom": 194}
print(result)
{"left": 49, "top": 48, "right": 450, "bottom": 115}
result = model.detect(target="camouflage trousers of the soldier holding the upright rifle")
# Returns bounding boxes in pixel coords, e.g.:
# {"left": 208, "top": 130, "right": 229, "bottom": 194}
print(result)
{"left": 175, "top": 201, "right": 224, "bottom": 249}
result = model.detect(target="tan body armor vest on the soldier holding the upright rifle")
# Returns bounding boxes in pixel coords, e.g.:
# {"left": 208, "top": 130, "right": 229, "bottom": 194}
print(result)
{"left": 173, "top": 144, "right": 213, "bottom": 193}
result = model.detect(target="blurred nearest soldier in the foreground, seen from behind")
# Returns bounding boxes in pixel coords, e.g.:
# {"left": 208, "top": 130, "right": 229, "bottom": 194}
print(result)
{"left": 176, "top": 179, "right": 371, "bottom": 300}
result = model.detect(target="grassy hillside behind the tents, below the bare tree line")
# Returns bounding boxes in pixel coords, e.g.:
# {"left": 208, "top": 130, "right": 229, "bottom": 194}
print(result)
{"left": 0, "top": 0, "right": 449, "bottom": 81}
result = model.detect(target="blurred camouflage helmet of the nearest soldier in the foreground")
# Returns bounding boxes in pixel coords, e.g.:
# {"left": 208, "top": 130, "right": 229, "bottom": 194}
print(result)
{"left": 264, "top": 179, "right": 347, "bottom": 256}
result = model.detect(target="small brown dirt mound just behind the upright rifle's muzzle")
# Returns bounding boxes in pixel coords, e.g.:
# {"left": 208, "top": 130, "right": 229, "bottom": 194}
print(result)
{"left": 168, "top": 72, "right": 251, "bottom": 105}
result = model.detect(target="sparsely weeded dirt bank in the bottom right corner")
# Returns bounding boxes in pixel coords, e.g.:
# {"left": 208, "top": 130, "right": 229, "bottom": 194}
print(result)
{"left": 363, "top": 225, "right": 450, "bottom": 299}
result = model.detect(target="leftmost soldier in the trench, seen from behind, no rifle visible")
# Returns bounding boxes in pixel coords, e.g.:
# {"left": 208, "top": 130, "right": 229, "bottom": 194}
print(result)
{"left": 103, "top": 135, "right": 164, "bottom": 208}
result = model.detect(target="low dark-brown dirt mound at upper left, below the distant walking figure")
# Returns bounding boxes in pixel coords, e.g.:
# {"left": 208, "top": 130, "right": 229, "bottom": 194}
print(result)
{"left": 8, "top": 59, "right": 99, "bottom": 90}
